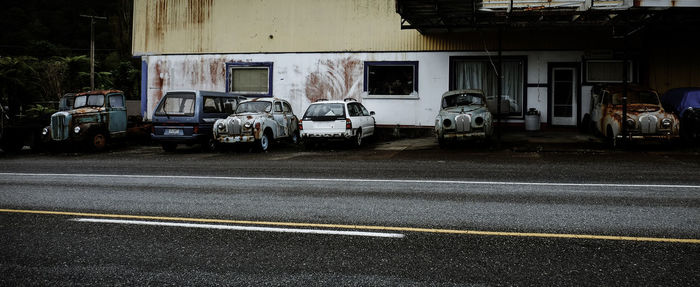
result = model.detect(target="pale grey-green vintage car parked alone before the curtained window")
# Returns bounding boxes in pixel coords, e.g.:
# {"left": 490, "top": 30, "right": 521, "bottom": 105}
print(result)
{"left": 435, "top": 90, "right": 493, "bottom": 146}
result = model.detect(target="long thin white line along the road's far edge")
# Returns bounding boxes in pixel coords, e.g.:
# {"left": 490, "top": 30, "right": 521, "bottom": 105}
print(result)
{"left": 0, "top": 172, "right": 700, "bottom": 189}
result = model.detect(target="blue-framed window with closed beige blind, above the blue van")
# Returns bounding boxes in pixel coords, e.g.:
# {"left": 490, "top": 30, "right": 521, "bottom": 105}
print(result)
{"left": 226, "top": 62, "right": 272, "bottom": 97}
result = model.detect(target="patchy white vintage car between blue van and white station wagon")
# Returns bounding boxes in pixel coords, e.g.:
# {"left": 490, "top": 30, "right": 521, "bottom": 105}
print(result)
{"left": 214, "top": 98, "right": 299, "bottom": 151}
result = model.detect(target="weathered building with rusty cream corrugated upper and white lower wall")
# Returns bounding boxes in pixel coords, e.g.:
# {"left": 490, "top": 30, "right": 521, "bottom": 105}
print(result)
{"left": 133, "top": 0, "right": 700, "bottom": 130}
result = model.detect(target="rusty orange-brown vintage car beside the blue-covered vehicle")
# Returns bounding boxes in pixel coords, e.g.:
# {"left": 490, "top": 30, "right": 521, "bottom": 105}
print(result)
{"left": 582, "top": 85, "right": 679, "bottom": 148}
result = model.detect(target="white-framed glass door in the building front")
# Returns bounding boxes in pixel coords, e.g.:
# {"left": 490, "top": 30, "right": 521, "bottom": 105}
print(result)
{"left": 550, "top": 67, "right": 578, "bottom": 126}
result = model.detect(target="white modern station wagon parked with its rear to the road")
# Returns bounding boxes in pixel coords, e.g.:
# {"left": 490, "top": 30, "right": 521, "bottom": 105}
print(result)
{"left": 299, "top": 98, "right": 375, "bottom": 147}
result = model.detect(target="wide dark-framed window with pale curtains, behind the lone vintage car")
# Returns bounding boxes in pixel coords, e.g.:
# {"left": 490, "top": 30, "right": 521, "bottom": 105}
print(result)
{"left": 450, "top": 57, "right": 526, "bottom": 117}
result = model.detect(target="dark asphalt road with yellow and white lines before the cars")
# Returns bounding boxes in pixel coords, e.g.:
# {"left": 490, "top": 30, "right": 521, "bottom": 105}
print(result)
{"left": 0, "top": 145, "right": 700, "bottom": 286}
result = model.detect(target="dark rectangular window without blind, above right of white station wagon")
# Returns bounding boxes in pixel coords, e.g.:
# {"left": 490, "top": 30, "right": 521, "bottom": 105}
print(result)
{"left": 364, "top": 62, "right": 418, "bottom": 97}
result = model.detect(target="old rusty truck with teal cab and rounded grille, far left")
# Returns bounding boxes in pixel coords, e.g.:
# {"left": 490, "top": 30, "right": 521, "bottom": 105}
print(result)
{"left": 42, "top": 90, "right": 127, "bottom": 151}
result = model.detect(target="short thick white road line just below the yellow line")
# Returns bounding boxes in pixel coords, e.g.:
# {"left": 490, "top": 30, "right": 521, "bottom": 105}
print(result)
{"left": 70, "top": 218, "right": 404, "bottom": 238}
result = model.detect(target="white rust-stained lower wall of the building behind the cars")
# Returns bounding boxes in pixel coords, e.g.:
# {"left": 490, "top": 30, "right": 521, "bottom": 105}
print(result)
{"left": 143, "top": 51, "right": 590, "bottom": 126}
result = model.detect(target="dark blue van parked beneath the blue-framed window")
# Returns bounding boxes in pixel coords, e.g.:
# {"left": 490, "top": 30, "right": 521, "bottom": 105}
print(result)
{"left": 151, "top": 90, "right": 245, "bottom": 151}
